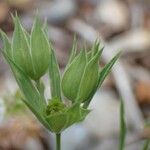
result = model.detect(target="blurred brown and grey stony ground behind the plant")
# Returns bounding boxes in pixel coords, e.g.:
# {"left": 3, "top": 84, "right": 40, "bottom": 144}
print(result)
{"left": 0, "top": 0, "right": 150, "bottom": 150}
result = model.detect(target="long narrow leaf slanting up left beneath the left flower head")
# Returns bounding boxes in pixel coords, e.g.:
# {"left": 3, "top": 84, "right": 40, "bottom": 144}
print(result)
{"left": 2, "top": 52, "right": 46, "bottom": 118}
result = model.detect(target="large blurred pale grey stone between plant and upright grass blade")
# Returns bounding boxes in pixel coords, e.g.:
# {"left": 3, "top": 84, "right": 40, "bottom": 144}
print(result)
{"left": 84, "top": 89, "right": 119, "bottom": 138}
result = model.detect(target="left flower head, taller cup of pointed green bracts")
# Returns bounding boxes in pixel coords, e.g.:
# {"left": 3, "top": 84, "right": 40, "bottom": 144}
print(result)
{"left": 2, "top": 17, "right": 51, "bottom": 80}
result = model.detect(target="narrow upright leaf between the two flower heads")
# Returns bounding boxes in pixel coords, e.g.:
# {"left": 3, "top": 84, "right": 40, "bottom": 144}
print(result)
{"left": 49, "top": 49, "right": 61, "bottom": 100}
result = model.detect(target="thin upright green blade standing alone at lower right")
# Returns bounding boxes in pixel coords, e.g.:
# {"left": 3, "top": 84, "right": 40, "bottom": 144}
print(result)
{"left": 119, "top": 100, "right": 126, "bottom": 150}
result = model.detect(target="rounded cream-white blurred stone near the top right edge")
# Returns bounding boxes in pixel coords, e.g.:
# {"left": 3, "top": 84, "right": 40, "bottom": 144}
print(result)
{"left": 95, "top": 1, "right": 129, "bottom": 30}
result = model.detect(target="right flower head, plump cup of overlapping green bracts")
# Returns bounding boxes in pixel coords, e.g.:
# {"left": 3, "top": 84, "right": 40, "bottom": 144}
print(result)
{"left": 62, "top": 42, "right": 101, "bottom": 102}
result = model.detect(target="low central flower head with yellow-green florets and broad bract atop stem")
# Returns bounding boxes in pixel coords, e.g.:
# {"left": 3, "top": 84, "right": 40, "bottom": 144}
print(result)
{"left": 46, "top": 98, "right": 90, "bottom": 133}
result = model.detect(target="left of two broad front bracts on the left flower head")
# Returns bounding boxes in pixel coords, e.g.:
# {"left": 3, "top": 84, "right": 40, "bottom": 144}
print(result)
{"left": 12, "top": 16, "right": 35, "bottom": 76}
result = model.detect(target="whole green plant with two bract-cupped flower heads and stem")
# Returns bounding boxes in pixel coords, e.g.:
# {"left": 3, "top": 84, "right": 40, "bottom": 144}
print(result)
{"left": 1, "top": 15, "right": 120, "bottom": 150}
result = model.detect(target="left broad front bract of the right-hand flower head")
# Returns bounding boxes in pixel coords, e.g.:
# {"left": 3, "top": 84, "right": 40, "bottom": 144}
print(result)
{"left": 61, "top": 50, "right": 86, "bottom": 101}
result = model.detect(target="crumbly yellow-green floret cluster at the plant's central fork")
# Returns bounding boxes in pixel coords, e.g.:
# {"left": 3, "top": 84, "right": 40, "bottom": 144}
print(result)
{"left": 46, "top": 98, "right": 66, "bottom": 116}
